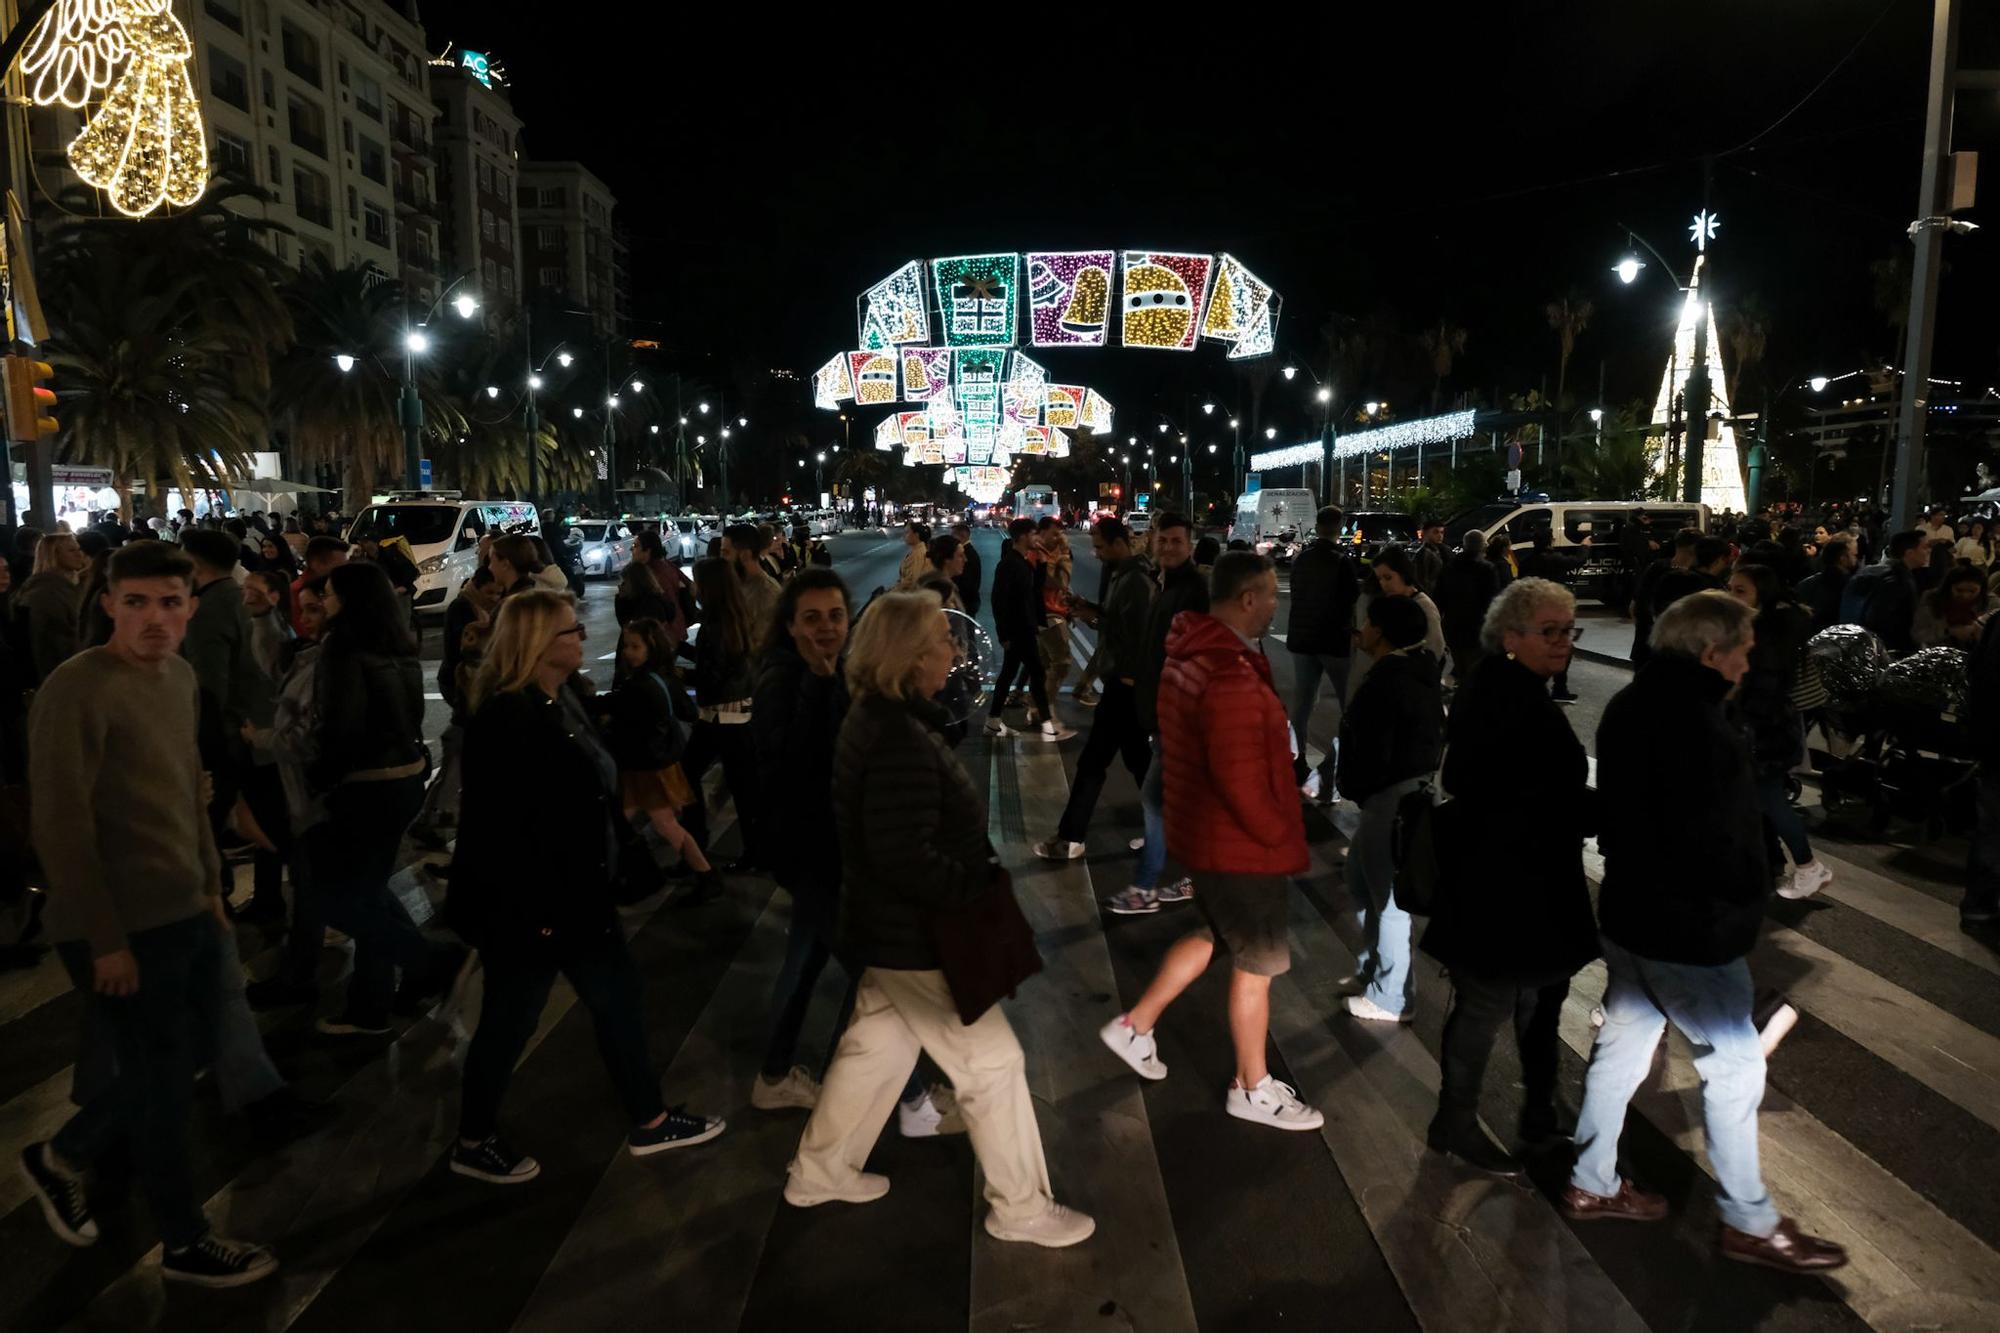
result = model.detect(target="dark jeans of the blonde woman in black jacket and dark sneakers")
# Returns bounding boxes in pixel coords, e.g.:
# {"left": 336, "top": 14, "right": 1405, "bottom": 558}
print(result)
{"left": 458, "top": 929, "right": 666, "bottom": 1139}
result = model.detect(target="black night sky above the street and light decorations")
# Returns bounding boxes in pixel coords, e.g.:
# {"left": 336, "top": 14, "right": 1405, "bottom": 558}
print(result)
{"left": 422, "top": 0, "right": 2000, "bottom": 446}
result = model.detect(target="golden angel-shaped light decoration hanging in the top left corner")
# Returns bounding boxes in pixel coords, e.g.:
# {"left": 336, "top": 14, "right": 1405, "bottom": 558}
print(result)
{"left": 20, "top": 0, "right": 208, "bottom": 218}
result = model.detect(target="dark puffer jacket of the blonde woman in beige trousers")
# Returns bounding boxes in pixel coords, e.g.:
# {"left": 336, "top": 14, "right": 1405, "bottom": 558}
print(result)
{"left": 834, "top": 695, "right": 998, "bottom": 971}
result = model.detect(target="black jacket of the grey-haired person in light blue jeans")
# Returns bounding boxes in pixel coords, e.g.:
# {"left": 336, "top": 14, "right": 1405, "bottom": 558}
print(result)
{"left": 1598, "top": 654, "right": 1770, "bottom": 967}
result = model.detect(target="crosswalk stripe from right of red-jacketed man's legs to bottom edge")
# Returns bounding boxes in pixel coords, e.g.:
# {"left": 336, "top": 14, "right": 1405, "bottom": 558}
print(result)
{"left": 1272, "top": 876, "right": 1646, "bottom": 1331}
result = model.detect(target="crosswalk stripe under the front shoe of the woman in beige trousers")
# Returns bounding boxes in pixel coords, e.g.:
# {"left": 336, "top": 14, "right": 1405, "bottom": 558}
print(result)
{"left": 972, "top": 741, "right": 1194, "bottom": 1333}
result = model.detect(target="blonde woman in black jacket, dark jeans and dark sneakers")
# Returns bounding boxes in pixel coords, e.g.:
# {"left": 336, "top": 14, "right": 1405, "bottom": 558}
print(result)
{"left": 444, "top": 588, "right": 722, "bottom": 1185}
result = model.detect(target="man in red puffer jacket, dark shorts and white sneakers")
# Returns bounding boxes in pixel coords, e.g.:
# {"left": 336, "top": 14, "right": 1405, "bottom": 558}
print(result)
{"left": 1100, "top": 550, "right": 1322, "bottom": 1129}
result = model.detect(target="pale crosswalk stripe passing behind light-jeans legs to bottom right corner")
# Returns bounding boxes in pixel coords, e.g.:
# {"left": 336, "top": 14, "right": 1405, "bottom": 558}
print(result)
{"left": 1560, "top": 963, "right": 2000, "bottom": 1329}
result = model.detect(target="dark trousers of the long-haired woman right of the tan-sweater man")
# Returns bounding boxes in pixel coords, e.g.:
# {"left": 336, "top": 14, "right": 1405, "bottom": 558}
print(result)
{"left": 308, "top": 775, "right": 432, "bottom": 1027}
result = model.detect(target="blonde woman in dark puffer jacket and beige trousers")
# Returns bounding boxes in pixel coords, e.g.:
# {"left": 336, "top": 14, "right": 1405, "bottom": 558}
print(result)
{"left": 784, "top": 592, "right": 1096, "bottom": 1247}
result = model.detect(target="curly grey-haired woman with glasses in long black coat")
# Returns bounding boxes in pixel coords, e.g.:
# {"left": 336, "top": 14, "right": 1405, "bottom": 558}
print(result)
{"left": 1422, "top": 578, "right": 1598, "bottom": 1175}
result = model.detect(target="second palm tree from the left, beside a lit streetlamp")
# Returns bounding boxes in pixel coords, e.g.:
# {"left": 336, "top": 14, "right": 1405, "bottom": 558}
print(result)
{"left": 272, "top": 254, "right": 464, "bottom": 512}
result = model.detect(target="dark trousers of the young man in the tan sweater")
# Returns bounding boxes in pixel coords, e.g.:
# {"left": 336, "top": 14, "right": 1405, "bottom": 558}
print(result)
{"left": 54, "top": 913, "right": 224, "bottom": 1249}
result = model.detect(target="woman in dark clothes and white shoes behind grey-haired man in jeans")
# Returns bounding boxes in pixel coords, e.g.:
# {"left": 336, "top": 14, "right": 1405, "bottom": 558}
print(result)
{"left": 1730, "top": 562, "right": 1832, "bottom": 899}
